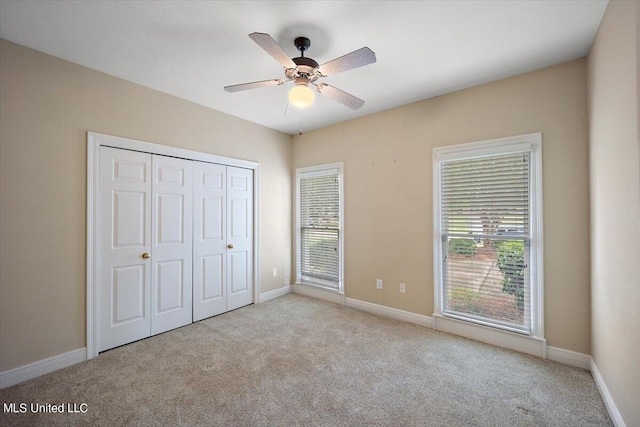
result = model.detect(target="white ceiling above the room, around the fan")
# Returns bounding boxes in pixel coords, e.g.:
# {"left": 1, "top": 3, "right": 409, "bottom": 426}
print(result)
{"left": 0, "top": 0, "right": 607, "bottom": 134}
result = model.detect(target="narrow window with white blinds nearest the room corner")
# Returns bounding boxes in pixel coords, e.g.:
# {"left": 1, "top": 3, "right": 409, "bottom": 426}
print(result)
{"left": 296, "top": 163, "right": 343, "bottom": 292}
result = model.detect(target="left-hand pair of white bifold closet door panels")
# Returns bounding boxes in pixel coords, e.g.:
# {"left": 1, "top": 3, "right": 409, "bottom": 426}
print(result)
{"left": 98, "top": 147, "right": 193, "bottom": 351}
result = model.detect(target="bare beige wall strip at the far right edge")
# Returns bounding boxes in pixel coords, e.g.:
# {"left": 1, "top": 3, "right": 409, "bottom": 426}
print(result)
{"left": 588, "top": 1, "right": 640, "bottom": 426}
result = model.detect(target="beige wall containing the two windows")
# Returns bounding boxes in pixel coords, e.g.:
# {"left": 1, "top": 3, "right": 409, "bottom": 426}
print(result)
{"left": 293, "top": 59, "right": 590, "bottom": 353}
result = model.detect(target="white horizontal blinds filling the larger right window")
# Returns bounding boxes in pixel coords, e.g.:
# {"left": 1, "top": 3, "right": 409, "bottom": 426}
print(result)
{"left": 440, "top": 152, "right": 531, "bottom": 333}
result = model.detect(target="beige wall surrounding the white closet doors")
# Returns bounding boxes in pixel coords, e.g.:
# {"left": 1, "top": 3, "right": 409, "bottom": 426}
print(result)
{"left": 0, "top": 40, "right": 291, "bottom": 371}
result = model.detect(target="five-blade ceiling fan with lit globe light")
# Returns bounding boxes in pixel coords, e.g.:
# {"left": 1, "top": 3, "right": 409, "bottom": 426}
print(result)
{"left": 224, "top": 33, "right": 376, "bottom": 110}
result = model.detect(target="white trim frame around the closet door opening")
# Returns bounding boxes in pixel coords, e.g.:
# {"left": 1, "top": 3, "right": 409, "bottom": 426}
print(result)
{"left": 86, "top": 132, "right": 260, "bottom": 359}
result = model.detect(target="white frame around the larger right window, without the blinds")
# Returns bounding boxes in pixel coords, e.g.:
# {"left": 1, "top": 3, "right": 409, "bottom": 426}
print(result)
{"left": 433, "top": 133, "right": 544, "bottom": 342}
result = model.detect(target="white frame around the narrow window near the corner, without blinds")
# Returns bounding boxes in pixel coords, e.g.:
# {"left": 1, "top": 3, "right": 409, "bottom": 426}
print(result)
{"left": 295, "top": 162, "right": 344, "bottom": 295}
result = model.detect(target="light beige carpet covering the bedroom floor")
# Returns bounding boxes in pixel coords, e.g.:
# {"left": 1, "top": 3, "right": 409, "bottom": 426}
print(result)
{"left": 0, "top": 295, "right": 611, "bottom": 426}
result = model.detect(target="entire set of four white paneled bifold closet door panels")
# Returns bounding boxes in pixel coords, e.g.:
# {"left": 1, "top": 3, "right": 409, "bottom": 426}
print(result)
{"left": 98, "top": 147, "right": 254, "bottom": 351}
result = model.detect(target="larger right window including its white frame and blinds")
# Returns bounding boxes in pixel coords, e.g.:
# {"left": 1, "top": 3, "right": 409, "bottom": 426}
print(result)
{"left": 434, "top": 134, "right": 543, "bottom": 338}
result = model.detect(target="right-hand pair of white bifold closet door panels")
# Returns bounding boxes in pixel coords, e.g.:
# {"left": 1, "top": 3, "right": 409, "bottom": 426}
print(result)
{"left": 193, "top": 162, "right": 253, "bottom": 322}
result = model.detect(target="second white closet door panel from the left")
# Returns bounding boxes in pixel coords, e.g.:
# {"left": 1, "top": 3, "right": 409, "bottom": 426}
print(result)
{"left": 151, "top": 155, "right": 193, "bottom": 335}
